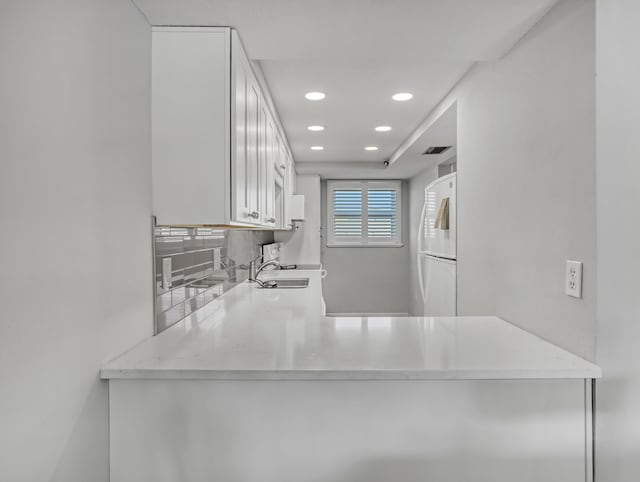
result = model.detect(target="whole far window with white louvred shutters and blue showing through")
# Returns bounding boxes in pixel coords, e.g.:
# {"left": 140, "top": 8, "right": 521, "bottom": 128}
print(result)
{"left": 327, "top": 181, "right": 402, "bottom": 246}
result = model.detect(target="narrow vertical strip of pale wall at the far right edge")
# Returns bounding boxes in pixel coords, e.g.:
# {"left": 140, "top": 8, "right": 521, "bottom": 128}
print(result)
{"left": 596, "top": 0, "right": 640, "bottom": 482}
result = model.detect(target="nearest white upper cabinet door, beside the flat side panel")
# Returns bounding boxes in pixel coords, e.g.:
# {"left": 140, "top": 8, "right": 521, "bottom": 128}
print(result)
{"left": 231, "top": 36, "right": 260, "bottom": 224}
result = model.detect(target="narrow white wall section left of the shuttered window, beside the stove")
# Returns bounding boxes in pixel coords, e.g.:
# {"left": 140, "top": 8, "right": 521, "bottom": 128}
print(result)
{"left": 274, "top": 175, "right": 321, "bottom": 267}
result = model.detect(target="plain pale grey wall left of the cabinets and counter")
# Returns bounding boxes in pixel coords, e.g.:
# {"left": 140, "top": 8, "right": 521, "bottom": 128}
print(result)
{"left": 0, "top": 0, "right": 153, "bottom": 482}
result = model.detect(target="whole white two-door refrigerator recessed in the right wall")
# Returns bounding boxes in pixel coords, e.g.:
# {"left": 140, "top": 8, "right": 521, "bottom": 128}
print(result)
{"left": 417, "top": 173, "right": 456, "bottom": 316}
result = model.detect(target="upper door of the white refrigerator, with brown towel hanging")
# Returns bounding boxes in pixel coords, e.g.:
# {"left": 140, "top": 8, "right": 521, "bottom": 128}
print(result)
{"left": 419, "top": 173, "right": 457, "bottom": 259}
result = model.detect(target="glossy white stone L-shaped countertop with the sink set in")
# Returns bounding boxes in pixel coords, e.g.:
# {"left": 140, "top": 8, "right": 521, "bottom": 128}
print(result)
{"left": 100, "top": 270, "right": 601, "bottom": 380}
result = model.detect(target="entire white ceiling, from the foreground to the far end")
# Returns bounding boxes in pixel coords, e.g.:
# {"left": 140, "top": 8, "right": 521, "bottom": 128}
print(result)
{"left": 134, "top": 0, "right": 556, "bottom": 177}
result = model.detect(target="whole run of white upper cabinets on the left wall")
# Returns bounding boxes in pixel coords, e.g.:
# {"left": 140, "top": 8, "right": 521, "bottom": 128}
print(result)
{"left": 152, "top": 27, "right": 293, "bottom": 229}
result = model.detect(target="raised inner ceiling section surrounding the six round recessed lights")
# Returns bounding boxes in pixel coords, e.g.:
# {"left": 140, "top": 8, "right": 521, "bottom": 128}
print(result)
{"left": 260, "top": 60, "right": 470, "bottom": 162}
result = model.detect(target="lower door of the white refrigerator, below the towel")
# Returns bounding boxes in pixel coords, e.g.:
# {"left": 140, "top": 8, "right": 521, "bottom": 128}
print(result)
{"left": 421, "top": 255, "right": 456, "bottom": 316}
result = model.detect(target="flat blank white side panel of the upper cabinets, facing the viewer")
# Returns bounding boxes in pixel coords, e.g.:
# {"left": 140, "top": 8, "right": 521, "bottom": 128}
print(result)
{"left": 151, "top": 27, "right": 233, "bottom": 226}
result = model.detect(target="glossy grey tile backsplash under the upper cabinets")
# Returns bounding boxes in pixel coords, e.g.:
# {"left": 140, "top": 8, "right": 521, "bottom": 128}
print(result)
{"left": 153, "top": 227, "right": 273, "bottom": 333}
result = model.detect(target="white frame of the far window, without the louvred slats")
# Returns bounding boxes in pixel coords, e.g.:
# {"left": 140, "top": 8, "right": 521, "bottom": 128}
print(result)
{"left": 326, "top": 180, "right": 403, "bottom": 248}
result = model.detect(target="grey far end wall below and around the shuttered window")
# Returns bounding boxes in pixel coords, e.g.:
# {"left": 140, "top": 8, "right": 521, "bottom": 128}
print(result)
{"left": 321, "top": 181, "right": 409, "bottom": 314}
